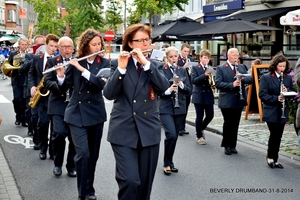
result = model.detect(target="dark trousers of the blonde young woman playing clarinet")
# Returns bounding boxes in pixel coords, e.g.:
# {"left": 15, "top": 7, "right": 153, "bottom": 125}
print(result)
{"left": 160, "top": 114, "right": 184, "bottom": 168}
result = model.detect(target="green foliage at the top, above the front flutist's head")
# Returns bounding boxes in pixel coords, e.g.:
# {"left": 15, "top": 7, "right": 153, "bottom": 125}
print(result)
{"left": 133, "top": 0, "right": 189, "bottom": 27}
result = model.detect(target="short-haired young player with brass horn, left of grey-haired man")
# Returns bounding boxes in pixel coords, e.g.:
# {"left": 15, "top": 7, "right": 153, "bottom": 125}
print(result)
{"left": 192, "top": 49, "right": 214, "bottom": 144}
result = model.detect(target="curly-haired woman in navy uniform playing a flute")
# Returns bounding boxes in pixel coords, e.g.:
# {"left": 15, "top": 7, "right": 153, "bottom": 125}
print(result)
{"left": 56, "top": 29, "right": 109, "bottom": 199}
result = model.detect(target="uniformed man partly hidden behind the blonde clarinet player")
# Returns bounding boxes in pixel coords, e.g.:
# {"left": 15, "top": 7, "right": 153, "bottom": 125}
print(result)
{"left": 177, "top": 43, "right": 195, "bottom": 136}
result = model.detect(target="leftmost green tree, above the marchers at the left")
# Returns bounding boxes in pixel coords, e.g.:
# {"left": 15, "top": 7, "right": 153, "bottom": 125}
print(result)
{"left": 25, "top": 0, "right": 65, "bottom": 36}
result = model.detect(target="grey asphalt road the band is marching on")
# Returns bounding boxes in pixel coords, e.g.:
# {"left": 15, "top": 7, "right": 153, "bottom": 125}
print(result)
{"left": 0, "top": 80, "right": 300, "bottom": 200}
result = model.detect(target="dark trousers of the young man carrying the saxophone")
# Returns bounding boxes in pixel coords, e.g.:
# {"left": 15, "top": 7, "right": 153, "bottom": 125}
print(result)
{"left": 36, "top": 103, "right": 52, "bottom": 154}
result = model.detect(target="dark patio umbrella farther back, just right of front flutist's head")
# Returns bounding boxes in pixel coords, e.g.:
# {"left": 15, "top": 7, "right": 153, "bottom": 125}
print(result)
{"left": 152, "top": 17, "right": 224, "bottom": 41}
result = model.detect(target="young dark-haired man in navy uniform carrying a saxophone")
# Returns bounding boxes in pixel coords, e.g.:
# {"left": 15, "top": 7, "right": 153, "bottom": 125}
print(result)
{"left": 28, "top": 34, "right": 59, "bottom": 160}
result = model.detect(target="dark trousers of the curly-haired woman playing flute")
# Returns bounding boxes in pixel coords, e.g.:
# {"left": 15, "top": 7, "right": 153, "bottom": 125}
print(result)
{"left": 69, "top": 123, "right": 104, "bottom": 197}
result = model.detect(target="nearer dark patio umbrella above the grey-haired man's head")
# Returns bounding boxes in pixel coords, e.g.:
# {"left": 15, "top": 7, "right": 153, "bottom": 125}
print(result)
{"left": 183, "top": 18, "right": 281, "bottom": 46}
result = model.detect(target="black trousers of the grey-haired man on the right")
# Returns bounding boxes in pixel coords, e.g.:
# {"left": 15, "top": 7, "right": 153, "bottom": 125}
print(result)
{"left": 221, "top": 108, "right": 243, "bottom": 148}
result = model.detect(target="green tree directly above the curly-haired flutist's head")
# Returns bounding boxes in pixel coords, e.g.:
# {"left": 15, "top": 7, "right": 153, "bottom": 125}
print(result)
{"left": 65, "top": 0, "right": 104, "bottom": 38}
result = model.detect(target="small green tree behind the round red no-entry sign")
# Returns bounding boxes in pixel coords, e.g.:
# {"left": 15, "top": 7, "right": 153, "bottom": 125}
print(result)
{"left": 105, "top": 0, "right": 123, "bottom": 33}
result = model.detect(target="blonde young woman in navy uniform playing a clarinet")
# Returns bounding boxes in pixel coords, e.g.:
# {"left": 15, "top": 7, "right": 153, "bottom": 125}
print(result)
{"left": 159, "top": 46, "right": 191, "bottom": 175}
